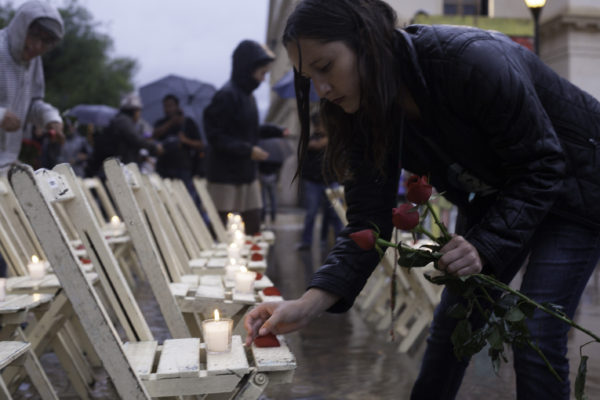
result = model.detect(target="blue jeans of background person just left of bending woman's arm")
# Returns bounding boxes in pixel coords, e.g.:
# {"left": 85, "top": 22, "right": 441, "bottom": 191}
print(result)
{"left": 302, "top": 179, "right": 342, "bottom": 245}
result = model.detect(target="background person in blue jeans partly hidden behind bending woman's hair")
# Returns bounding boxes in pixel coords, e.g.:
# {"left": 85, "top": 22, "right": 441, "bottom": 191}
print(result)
{"left": 298, "top": 112, "right": 342, "bottom": 250}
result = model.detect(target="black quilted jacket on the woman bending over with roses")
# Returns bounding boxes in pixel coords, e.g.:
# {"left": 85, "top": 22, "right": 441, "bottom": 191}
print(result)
{"left": 310, "top": 26, "right": 600, "bottom": 311}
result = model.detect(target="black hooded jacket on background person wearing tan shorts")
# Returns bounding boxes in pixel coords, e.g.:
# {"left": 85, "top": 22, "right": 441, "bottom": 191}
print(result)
{"left": 204, "top": 41, "right": 272, "bottom": 184}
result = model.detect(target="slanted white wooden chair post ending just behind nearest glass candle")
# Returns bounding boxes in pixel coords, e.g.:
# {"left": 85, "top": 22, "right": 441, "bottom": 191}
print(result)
{"left": 104, "top": 158, "right": 191, "bottom": 338}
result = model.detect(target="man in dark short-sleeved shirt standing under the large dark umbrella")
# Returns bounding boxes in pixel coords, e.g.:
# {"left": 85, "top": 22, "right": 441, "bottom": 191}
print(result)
{"left": 152, "top": 94, "right": 204, "bottom": 206}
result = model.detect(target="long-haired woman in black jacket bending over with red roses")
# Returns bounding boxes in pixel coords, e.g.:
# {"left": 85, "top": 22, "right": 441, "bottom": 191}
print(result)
{"left": 245, "top": 0, "right": 600, "bottom": 400}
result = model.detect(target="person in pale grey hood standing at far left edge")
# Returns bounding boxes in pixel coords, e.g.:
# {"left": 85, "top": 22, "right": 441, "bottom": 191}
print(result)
{"left": 0, "top": 0, "right": 64, "bottom": 174}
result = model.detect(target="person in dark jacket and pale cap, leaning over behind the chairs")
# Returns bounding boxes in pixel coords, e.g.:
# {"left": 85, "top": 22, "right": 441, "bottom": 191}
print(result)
{"left": 86, "top": 93, "right": 163, "bottom": 177}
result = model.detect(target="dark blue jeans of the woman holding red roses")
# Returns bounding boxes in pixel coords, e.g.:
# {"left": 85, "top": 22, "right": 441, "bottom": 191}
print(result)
{"left": 411, "top": 216, "right": 600, "bottom": 400}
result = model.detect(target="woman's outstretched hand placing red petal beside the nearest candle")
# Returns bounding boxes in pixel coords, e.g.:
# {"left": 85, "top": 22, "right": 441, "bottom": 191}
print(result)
{"left": 244, "top": 288, "right": 338, "bottom": 345}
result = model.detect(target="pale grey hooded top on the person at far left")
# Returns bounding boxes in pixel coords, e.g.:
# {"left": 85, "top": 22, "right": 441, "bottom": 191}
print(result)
{"left": 0, "top": 1, "right": 63, "bottom": 173}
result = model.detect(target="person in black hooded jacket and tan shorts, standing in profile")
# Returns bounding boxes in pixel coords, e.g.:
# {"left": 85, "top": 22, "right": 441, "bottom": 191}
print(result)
{"left": 204, "top": 40, "right": 274, "bottom": 235}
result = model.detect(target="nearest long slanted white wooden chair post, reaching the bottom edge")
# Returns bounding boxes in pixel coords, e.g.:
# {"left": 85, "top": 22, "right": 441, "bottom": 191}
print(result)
{"left": 10, "top": 166, "right": 150, "bottom": 399}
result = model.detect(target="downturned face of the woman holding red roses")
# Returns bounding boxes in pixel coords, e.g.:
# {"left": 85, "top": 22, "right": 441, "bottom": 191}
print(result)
{"left": 287, "top": 39, "right": 360, "bottom": 114}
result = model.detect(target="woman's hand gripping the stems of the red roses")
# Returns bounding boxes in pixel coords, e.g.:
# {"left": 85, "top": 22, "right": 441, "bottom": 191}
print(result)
{"left": 438, "top": 235, "right": 483, "bottom": 276}
